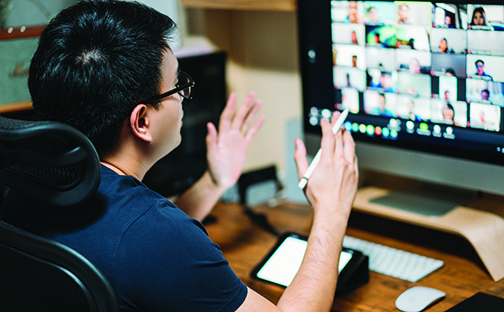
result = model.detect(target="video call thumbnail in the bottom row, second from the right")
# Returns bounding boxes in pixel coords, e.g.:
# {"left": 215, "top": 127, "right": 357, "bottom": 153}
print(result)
{"left": 431, "top": 99, "right": 467, "bottom": 127}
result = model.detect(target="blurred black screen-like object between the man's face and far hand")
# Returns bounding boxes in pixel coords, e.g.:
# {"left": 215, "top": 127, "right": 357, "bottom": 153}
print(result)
{"left": 143, "top": 52, "right": 227, "bottom": 197}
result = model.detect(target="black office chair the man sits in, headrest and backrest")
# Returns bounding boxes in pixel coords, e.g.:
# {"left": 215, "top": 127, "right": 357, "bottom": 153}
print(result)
{"left": 0, "top": 117, "right": 118, "bottom": 312}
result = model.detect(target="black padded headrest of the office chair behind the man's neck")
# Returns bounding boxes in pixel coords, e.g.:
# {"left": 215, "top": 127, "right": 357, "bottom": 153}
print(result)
{"left": 0, "top": 117, "right": 100, "bottom": 207}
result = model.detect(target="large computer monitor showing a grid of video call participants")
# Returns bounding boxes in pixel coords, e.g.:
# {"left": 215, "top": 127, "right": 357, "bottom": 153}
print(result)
{"left": 298, "top": 0, "right": 504, "bottom": 213}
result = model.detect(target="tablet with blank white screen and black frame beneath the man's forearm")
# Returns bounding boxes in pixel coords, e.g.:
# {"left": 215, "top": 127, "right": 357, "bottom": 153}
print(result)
{"left": 251, "top": 233, "right": 361, "bottom": 287}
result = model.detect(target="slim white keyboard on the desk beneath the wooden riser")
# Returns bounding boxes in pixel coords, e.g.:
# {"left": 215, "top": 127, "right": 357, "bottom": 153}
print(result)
{"left": 343, "top": 236, "right": 444, "bottom": 282}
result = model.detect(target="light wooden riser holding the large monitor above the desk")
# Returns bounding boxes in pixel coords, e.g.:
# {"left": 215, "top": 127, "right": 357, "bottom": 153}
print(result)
{"left": 353, "top": 173, "right": 504, "bottom": 282}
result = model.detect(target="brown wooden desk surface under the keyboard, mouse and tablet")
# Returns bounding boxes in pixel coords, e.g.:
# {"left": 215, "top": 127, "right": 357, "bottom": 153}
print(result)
{"left": 206, "top": 203, "right": 504, "bottom": 312}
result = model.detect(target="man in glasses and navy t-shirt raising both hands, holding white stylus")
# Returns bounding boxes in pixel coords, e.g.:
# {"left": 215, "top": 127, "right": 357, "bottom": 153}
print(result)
{"left": 4, "top": 0, "right": 358, "bottom": 311}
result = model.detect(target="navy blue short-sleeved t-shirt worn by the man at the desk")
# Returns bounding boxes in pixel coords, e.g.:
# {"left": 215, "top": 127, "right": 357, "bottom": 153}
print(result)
{"left": 4, "top": 166, "right": 247, "bottom": 311}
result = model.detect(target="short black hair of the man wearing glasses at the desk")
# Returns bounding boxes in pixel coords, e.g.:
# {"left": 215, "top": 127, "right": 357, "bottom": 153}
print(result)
{"left": 28, "top": 0, "right": 177, "bottom": 155}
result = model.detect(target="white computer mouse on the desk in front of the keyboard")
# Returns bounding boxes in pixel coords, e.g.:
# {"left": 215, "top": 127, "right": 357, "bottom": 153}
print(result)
{"left": 396, "top": 286, "right": 446, "bottom": 312}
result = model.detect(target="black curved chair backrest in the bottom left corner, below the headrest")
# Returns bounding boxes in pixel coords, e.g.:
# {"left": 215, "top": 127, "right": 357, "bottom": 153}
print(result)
{"left": 0, "top": 221, "right": 118, "bottom": 312}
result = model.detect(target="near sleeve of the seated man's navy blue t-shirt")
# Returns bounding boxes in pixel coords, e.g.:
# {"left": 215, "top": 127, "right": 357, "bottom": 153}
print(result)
{"left": 112, "top": 201, "right": 247, "bottom": 311}
